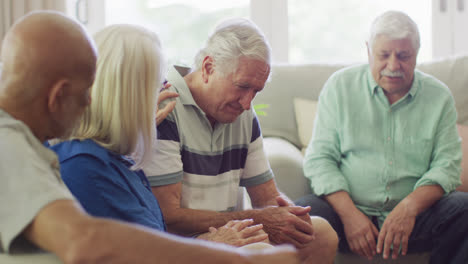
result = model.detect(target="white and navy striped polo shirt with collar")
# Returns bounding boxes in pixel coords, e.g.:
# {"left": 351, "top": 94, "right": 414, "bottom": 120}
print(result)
{"left": 144, "top": 66, "right": 273, "bottom": 211}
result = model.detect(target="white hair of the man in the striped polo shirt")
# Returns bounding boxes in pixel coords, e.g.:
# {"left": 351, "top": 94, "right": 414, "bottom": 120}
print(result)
{"left": 193, "top": 18, "right": 271, "bottom": 75}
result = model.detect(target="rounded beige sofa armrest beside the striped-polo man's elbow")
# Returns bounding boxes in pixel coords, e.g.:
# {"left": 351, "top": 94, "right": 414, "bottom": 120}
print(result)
{"left": 263, "top": 137, "right": 311, "bottom": 200}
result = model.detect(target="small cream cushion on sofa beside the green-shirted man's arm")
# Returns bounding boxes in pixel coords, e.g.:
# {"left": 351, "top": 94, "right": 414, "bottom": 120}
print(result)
{"left": 294, "top": 97, "right": 317, "bottom": 152}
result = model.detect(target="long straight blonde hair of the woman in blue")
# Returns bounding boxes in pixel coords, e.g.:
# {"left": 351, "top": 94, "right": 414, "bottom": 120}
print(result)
{"left": 72, "top": 25, "right": 165, "bottom": 169}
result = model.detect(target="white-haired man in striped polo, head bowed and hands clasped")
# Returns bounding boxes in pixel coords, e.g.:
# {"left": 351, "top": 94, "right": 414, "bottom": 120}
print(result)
{"left": 144, "top": 19, "right": 338, "bottom": 263}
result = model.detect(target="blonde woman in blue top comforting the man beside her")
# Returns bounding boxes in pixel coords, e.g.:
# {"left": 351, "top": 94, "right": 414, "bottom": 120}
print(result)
{"left": 51, "top": 25, "right": 267, "bottom": 246}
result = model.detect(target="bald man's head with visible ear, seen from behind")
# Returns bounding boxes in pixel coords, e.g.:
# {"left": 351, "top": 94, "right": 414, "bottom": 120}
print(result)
{"left": 0, "top": 11, "right": 97, "bottom": 140}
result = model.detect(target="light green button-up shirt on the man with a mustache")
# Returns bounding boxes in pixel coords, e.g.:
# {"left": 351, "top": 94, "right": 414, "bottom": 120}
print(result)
{"left": 304, "top": 65, "right": 462, "bottom": 225}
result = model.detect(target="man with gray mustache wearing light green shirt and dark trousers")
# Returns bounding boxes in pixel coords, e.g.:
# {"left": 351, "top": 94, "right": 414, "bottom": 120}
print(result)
{"left": 296, "top": 11, "right": 468, "bottom": 263}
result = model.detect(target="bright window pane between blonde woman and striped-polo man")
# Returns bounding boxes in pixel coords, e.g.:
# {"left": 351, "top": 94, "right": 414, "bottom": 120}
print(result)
{"left": 105, "top": 0, "right": 249, "bottom": 65}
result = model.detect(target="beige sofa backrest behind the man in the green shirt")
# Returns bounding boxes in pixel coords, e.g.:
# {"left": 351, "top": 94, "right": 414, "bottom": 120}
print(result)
{"left": 254, "top": 56, "right": 468, "bottom": 147}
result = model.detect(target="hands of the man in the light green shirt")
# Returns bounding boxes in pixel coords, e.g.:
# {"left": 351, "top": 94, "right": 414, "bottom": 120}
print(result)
{"left": 342, "top": 203, "right": 416, "bottom": 260}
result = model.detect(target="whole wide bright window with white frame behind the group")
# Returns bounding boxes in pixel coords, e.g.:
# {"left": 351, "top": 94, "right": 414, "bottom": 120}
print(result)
{"left": 67, "top": 0, "right": 446, "bottom": 65}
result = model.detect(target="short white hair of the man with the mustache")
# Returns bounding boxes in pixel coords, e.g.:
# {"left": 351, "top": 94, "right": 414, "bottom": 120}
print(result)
{"left": 369, "top": 11, "right": 421, "bottom": 51}
